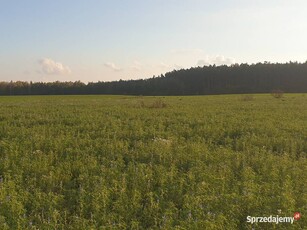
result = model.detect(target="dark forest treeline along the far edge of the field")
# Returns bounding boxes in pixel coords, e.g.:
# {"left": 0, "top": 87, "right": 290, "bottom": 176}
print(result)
{"left": 0, "top": 62, "right": 307, "bottom": 95}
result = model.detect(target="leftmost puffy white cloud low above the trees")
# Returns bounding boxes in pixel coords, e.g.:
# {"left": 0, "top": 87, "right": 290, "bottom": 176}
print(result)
{"left": 38, "top": 58, "right": 71, "bottom": 75}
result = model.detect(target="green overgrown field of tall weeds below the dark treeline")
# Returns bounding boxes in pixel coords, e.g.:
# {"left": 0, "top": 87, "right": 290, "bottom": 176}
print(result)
{"left": 0, "top": 94, "right": 307, "bottom": 229}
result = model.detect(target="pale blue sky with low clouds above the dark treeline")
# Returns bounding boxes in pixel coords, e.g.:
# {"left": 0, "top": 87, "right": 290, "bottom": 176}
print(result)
{"left": 0, "top": 0, "right": 307, "bottom": 83}
